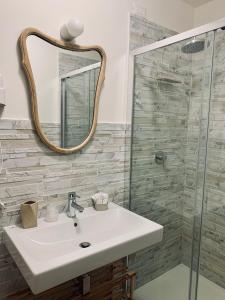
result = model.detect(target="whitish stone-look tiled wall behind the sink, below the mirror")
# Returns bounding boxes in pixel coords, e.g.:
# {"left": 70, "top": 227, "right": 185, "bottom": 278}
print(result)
{"left": 0, "top": 120, "right": 125, "bottom": 299}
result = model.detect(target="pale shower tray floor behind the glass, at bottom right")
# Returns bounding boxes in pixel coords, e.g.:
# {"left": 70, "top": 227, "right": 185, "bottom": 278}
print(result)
{"left": 134, "top": 264, "right": 225, "bottom": 300}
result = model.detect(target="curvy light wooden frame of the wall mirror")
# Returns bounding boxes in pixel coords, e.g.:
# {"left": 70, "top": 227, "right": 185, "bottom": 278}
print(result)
{"left": 19, "top": 28, "right": 106, "bottom": 154}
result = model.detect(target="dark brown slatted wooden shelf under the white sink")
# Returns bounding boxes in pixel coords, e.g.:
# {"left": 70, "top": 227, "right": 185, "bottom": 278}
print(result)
{"left": 7, "top": 259, "right": 136, "bottom": 300}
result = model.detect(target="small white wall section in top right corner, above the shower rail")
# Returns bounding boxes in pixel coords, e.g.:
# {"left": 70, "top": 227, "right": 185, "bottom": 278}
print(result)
{"left": 194, "top": 0, "right": 225, "bottom": 27}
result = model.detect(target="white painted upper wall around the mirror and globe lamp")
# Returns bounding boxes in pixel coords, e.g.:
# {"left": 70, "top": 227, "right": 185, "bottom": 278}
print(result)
{"left": 0, "top": 0, "right": 193, "bottom": 123}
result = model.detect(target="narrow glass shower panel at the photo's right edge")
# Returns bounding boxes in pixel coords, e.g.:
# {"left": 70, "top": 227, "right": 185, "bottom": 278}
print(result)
{"left": 198, "top": 30, "right": 225, "bottom": 300}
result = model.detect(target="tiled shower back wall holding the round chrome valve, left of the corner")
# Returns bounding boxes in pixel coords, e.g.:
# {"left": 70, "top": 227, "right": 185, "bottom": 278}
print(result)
{"left": 130, "top": 16, "right": 190, "bottom": 286}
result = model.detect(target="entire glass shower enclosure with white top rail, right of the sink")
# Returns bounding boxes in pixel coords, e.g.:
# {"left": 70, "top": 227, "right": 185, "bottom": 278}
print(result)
{"left": 129, "top": 20, "right": 225, "bottom": 300}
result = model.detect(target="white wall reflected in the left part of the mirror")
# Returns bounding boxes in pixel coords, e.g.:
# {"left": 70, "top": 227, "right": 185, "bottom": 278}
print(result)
{"left": 27, "top": 35, "right": 61, "bottom": 123}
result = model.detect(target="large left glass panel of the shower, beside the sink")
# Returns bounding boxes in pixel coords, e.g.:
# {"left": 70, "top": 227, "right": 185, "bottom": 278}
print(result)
{"left": 129, "top": 33, "right": 216, "bottom": 300}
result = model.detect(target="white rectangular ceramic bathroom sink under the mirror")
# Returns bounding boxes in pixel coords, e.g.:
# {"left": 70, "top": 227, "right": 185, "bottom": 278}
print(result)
{"left": 4, "top": 204, "right": 163, "bottom": 294}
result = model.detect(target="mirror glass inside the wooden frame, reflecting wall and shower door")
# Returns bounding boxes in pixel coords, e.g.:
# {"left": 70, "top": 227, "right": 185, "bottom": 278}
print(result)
{"left": 27, "top": 35, "right": 101, "bottom": 148}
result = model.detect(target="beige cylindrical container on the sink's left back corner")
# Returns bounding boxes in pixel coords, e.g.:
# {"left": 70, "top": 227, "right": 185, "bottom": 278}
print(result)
{"left": 20, "top": 201, "right": 38, "bottom": 228}
